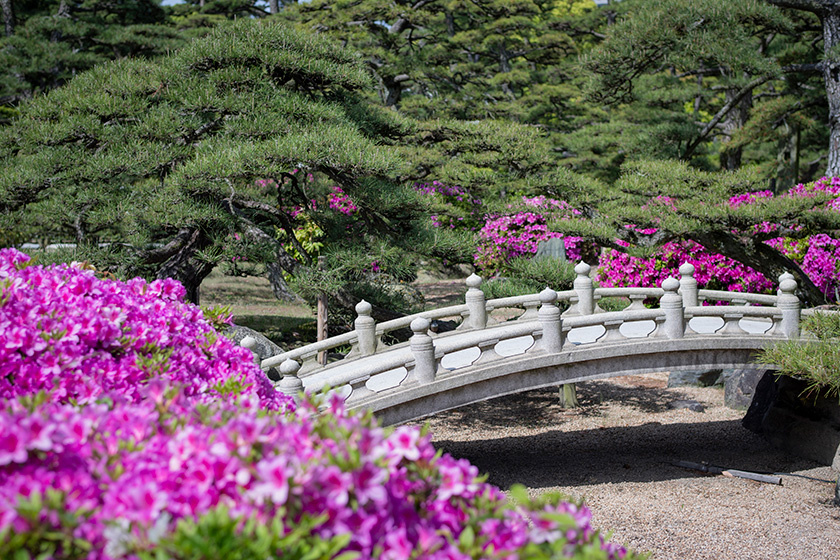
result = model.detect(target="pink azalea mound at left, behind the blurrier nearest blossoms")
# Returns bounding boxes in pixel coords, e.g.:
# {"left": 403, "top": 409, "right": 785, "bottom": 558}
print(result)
{"left": 0, "top": 249, "right": 288, "bottom": 408}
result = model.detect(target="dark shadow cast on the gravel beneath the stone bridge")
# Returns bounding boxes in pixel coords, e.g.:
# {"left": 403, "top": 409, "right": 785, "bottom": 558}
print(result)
{"left": 431, "top": 382, "right": 818, "bottom": 489}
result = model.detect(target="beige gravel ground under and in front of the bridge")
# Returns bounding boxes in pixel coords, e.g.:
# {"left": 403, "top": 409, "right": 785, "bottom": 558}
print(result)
{"left": 428, "top": 373, "right": 840, "bottom": 560}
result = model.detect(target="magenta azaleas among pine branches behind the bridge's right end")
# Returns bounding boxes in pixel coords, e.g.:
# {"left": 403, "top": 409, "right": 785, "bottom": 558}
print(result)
{"left": 596, "top": 177, "right": 840, "bottom": 299}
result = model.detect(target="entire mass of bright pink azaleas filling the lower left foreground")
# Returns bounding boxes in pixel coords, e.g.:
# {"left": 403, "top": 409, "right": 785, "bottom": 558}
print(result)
{"left": 0, "top": 249, "right": 634, "bottom": 560}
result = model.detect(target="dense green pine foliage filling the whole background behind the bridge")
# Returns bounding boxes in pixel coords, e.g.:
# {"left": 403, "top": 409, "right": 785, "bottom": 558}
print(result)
{"left": 0, "top": 0, "right": 840, "bottom": 304}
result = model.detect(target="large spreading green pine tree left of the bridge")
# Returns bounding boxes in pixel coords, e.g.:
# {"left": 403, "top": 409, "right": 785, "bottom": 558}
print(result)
{"left": 0, "top": 20, "right": 547, "bottom": 306}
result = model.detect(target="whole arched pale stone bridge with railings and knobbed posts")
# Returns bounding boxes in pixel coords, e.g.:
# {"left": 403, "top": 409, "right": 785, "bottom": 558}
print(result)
{"left": 243, "top": 263, "right": 800, "bottom": 423}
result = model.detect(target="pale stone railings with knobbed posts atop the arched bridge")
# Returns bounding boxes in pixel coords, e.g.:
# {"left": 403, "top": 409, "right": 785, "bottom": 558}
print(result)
{"left": 253, "top": 263, "right": 800, "bottom": 402}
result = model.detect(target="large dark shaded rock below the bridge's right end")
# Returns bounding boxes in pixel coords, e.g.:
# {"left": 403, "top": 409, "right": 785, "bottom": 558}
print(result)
{"left": 742, "top": 372, "right": 840, "bottom": 470}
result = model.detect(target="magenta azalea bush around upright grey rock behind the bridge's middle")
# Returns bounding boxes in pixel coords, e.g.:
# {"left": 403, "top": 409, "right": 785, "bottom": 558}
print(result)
{"left": 475, "top": 196, "right": 583, "bottom": 273}
